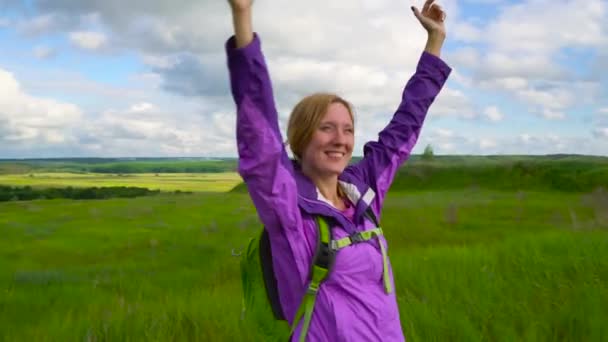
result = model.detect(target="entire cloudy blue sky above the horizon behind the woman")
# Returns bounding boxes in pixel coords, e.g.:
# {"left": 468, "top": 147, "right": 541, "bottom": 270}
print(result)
{"left": 0, "top": 0, "right": 608, "bottom": 158}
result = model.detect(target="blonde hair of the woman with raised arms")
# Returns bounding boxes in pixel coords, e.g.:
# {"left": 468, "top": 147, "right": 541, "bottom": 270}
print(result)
{"left": 287, "top": 93, "right": 355, "bottom": 161}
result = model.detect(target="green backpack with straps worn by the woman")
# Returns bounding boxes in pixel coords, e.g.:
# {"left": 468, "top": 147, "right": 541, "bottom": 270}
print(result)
{"left": 240, "top": 210, "right": 392, "bottom": 342}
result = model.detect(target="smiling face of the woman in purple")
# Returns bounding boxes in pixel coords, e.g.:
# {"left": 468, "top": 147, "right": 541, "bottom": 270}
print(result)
{"left": 302, "top": 103, "right": 355, "bottom": 178}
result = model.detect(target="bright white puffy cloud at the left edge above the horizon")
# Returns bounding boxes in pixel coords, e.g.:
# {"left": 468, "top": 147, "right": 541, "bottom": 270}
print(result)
{"left": 0, "top": 69, "right": 82, "bottom": 150}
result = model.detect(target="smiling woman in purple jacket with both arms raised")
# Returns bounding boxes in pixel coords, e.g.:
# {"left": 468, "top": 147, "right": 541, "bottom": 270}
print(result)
{"left": 226, "top": 0, "right": 451, "bottom": 341}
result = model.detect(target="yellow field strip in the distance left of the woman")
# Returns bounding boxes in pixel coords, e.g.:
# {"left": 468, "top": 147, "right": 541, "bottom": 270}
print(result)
{"left": 0, "top": 172, "right": 241, "bottom": 192}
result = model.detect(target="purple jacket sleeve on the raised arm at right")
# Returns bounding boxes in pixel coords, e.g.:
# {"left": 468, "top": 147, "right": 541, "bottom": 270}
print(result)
{"left": 349, "top": 51, "right": 451, "bottom": 203}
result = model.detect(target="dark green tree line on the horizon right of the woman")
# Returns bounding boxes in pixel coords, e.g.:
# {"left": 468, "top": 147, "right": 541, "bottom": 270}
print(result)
{"left": 231, "top": 157, "right": 608, "bottom": 193}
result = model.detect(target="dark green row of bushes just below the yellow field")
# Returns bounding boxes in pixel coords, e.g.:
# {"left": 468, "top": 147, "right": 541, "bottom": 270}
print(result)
{"left": 0, "top": 185, "right": 180, "bottom": 202}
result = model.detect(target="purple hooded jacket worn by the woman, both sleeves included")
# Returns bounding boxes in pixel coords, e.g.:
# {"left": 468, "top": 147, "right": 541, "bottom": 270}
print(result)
{"left": 226, "top": 34, "right": 451, "bottom": 341}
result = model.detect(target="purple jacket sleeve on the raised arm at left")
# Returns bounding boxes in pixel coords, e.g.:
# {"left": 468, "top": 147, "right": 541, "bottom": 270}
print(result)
{"left": 226, "top": 34, "right": 301, "bottom": 233}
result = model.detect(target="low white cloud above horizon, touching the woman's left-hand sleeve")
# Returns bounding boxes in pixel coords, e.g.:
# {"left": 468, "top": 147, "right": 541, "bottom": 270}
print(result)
{"left": 79, "top": 103, "right": 236, "bottom": 156}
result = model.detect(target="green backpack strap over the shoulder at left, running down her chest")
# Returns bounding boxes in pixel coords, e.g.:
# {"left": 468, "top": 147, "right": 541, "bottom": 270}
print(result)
{"left": 290, "top": 216, "right": 334, "bottom": 342}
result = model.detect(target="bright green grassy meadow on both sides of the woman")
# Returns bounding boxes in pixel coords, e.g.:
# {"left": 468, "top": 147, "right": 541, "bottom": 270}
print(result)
{"left": 0, "top": 157, "right": 608, "bottom": 341}
